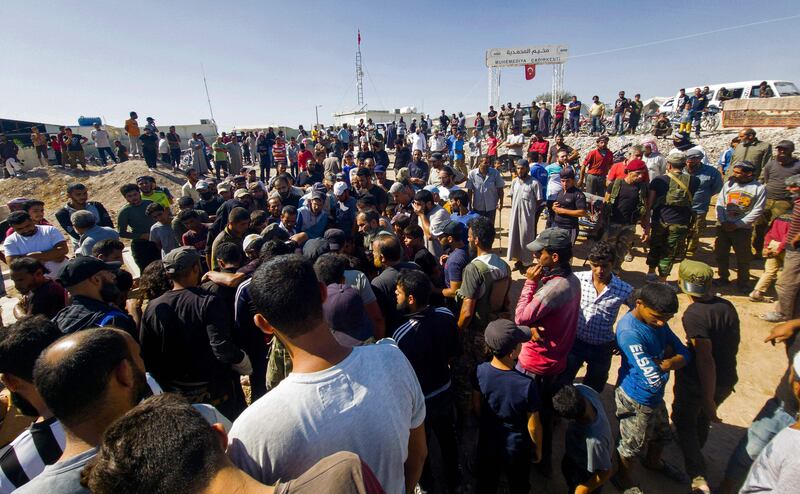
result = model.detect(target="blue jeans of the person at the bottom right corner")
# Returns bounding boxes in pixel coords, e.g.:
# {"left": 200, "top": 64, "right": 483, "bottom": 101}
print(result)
{"left": 725, "top": 397, "right": 795, "bottom": 486}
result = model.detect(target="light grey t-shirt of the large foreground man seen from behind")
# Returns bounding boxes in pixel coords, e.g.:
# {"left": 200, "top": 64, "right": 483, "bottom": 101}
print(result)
{"left": 228, "top": 340, "right": 425, "bottom": 494}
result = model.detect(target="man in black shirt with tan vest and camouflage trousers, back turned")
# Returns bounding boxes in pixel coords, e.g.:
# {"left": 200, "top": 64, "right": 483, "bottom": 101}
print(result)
{"left": 642, "top": 151, "right": 700, "bottom": 282}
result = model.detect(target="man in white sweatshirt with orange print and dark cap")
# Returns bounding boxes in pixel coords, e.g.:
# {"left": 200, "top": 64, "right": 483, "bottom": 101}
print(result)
{"left": 714, "top": 161, "right": 767, "bottom": 294}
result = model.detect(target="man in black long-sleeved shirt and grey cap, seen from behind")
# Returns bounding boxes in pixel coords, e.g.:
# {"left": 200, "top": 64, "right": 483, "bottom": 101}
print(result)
{"left": 141, "top": 247, "right": 253, "bottom": 419}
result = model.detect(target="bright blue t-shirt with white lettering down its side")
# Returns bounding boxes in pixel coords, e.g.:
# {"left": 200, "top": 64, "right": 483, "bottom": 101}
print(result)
{"left": 617, "top": 311, "right": 691, "bottom": 407}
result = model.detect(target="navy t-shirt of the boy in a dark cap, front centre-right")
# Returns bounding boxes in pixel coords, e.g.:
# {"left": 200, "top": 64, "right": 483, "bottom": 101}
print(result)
{"left": 472, "top": 362, "right": 539, "bottom": 456}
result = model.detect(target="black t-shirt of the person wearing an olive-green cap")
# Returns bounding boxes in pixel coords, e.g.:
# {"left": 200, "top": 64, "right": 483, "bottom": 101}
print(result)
{"left": 676, "top": 296, "right": 739, "bottom": 387}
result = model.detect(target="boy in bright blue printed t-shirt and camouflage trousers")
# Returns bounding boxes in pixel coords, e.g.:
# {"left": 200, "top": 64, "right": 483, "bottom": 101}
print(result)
{"left": 612, "top": 283, "right": 689, "bottom": 490}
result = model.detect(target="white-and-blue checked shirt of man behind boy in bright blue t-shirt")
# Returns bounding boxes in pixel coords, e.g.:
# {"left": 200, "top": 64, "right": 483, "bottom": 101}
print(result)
{"left": 575, "top": 271, "right": 633, "bottom": 345}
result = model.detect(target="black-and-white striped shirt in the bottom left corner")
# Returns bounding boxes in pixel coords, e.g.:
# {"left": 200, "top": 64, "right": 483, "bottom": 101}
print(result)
{"left": 0, "top": 417, "right": 66, "bottom": 494}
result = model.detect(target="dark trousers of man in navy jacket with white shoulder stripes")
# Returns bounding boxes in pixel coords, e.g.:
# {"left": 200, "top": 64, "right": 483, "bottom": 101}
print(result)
{"left": 419, "top": 388, "right": 461, "bottom": 492}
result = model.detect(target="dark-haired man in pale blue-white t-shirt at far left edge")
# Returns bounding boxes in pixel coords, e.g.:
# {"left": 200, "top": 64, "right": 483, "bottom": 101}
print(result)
{"left": 3, "top": 211, "right": 69, "bottom": 278}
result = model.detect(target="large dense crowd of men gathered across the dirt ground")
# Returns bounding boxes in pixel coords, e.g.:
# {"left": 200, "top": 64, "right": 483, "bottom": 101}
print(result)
{"left": 0, "top": 100, "right": 800, "bottom": 494}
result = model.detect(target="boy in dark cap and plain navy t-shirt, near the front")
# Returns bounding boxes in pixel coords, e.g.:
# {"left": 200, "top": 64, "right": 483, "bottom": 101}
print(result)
{"left": 472, "top": 319, "right": 542, "bottom": 494}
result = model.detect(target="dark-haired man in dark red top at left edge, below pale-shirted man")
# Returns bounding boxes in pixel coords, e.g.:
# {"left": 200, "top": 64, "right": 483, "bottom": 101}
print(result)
{"left": 10, "top": 257, "right": 67, "bottom": 319}
